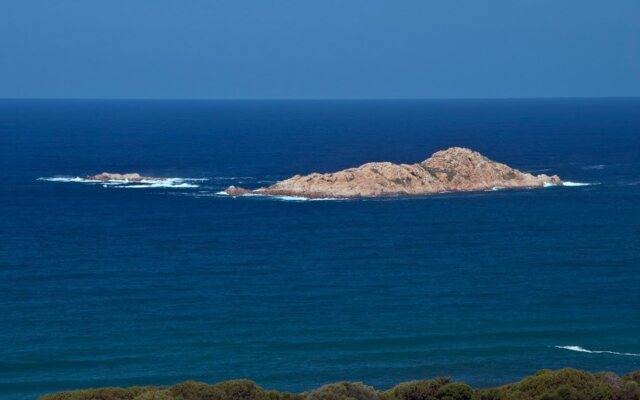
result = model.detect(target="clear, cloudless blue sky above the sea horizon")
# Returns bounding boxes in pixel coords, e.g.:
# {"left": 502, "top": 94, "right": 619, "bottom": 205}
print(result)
{"left": 0, "top": 0, "right": 640, "bottom": 98}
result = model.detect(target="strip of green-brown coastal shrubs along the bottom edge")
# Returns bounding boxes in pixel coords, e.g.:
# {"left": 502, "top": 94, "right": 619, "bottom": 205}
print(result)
{"left": 40, "top": 368, "right": 640, "bottom": 400}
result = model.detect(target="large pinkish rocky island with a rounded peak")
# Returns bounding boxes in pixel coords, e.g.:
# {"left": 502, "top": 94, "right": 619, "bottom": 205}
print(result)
{"left": 225, "top": 147, "right": 562, "bottom": 199}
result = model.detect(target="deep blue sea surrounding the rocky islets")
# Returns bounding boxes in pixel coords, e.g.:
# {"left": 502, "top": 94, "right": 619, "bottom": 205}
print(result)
{"left": 0, "top": 99, "right": 640, "bottom": 399}
